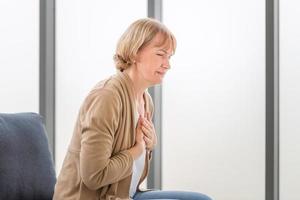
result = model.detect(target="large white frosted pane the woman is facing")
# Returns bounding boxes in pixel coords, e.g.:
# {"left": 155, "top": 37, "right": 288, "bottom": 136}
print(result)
{"left": 162, "top": 0, "right": 265, "bottom": 200}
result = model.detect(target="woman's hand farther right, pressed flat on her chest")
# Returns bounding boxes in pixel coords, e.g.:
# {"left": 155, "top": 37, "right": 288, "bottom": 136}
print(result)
{"left": 142, "top": 113, "right": 157, "bottom": 150}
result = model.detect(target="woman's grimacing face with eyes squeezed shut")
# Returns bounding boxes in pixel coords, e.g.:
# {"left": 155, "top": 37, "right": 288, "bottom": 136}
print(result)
{"left": 136, "top": 34, "right": 173, "bottom": 85}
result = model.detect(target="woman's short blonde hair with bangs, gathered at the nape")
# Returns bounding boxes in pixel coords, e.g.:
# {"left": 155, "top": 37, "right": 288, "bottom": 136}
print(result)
{"left": 113, "top": 18, "right": 176, "bottom": 71}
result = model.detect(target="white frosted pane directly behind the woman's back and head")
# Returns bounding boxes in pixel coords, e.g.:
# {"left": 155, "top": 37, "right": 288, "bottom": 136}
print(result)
{"left": 55, "top": 0, "right": 147, "bottom": 175}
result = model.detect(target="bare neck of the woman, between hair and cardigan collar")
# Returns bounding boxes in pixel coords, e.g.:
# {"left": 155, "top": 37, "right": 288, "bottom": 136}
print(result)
{"left": 124, "top": 66, "right": 149, "bottom": 102}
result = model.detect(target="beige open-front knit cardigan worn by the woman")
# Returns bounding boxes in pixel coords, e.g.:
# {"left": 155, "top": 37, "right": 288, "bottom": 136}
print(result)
{"left": 53, "top": 71, "right": 153, "bottom": 200}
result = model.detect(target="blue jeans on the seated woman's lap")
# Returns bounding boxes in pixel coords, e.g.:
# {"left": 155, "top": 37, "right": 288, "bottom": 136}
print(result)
{"left": 133, "top": 190, "right": 212, "bottom": 200}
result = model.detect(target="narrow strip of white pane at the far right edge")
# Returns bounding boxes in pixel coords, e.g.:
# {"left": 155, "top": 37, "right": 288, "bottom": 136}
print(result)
{"left": 279, "top": 0, "right": 300, "bottom": 200}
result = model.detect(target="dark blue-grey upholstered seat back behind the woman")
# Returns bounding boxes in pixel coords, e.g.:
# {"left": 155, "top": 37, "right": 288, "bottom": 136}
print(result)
{"left": 0, "top": 113, "right": 56, "bottom": 200}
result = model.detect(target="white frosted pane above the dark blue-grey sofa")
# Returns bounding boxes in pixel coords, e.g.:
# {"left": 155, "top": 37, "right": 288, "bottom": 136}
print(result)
{"left": 0, "top": 0, "right": 39, "bottom": 113}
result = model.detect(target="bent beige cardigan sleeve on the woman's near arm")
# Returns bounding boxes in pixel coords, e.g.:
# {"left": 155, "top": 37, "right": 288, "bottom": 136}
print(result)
{"left": 80, "top": 90, "right": 134, "bottom": 190}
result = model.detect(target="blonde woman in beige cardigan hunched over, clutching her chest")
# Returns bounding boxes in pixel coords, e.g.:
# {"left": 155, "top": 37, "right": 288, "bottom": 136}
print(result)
{"left": 54, "top": 18, "right": 209, "bottom": 200}
